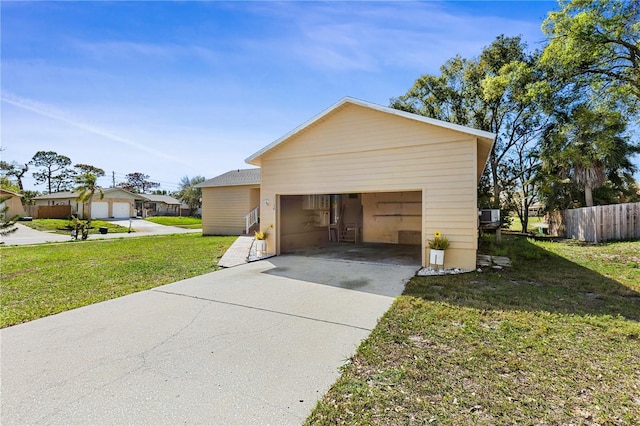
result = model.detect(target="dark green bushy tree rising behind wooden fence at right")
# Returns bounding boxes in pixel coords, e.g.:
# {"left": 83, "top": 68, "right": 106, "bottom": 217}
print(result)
{"left": 541, "top": 103, "right": 640, "bottom": 208}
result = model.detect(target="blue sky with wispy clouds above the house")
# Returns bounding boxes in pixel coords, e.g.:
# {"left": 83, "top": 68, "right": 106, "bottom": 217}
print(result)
{"left": 0, "top": 1, "right": 568, "bottom": 190}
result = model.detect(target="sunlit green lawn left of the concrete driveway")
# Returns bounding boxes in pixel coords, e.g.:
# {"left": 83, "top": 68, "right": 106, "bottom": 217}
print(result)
{"left": 0, "top": 234, "right": 235, "bottom": 327}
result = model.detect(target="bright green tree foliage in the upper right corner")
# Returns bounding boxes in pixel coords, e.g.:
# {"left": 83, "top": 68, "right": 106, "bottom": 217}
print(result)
{"left": 542, "top": 0, "right": 640, "bottom": 106}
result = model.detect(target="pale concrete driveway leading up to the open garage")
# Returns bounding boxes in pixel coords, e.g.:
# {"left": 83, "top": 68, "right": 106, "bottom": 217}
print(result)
{"left": 0, "top": 256, "right": 417, "bottom": 425}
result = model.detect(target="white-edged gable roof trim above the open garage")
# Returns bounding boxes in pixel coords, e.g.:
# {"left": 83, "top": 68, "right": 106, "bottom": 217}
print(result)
{"left": 245, "top": 97, "right": 496, "bottom": 166}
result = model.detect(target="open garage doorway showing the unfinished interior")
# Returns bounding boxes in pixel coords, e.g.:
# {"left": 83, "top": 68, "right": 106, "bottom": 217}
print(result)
{"left": 279, "top": 191, "right": 422, "bottom": 265}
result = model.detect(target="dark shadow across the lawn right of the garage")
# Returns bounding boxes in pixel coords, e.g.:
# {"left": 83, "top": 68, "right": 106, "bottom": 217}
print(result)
{"left": 403, "top": 236, "right": 640, "bottom": 321}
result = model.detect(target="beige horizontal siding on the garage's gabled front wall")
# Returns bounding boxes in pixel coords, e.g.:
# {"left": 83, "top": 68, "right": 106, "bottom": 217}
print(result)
{"left": 261, "top": 104, "right": 479, "bottom": 269}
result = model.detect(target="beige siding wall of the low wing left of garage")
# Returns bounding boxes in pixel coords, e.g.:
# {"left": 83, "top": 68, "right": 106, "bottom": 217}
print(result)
{"left": 202, "top": 185, "right": 260, "bottom": 235}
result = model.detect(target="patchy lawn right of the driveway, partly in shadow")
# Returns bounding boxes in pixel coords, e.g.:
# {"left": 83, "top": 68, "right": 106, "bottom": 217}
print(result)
{"left": 307, "top": 236, "right": 640, "bottom": 425}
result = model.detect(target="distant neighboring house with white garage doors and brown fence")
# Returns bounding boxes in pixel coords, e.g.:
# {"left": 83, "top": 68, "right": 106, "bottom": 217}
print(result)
{"left": 33, "top": 188, "right": 144, "bottom": 219}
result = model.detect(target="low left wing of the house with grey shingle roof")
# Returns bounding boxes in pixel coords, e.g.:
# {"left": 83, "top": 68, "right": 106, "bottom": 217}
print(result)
{"left": 197, "top": 169, "right": 260, "bottom": 235}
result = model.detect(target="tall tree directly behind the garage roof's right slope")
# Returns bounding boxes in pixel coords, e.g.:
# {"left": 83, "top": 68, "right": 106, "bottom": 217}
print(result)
{"left": 391, "top": 36, "right": 546, "bottom": 207}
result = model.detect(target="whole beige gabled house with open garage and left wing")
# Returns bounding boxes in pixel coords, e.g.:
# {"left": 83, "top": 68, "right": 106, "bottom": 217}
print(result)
{"left": 235, "top": 98, "right": 495, "bottom": 269}
